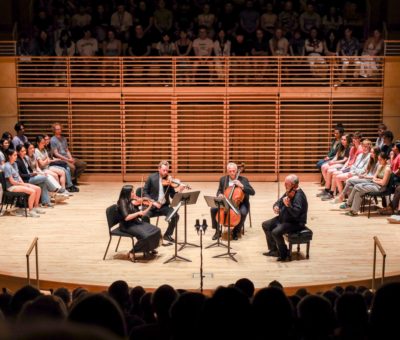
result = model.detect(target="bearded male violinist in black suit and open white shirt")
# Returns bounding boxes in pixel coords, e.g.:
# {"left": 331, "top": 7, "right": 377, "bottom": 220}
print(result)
{"left": 143, "top": 161, "right": 184, "bottom": 242}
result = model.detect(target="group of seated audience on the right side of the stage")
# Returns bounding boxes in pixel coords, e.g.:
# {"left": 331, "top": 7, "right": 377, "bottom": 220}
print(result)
{"left": 317, "top": 124, "right": 400, "bottom": 223}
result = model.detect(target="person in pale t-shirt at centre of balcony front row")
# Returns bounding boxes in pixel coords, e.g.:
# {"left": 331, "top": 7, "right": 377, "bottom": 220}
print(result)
{"left": 193, "top": 27, "right": 214, "bottom": 81}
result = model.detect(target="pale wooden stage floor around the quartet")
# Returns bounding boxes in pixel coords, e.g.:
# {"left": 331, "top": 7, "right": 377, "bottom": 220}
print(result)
{"left": 0, "top": 182, "right": 400, "bottom": 289}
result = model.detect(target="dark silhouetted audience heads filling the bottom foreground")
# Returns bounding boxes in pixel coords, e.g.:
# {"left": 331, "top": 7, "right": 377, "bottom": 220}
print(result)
{"left": 0, "top": 278, "right": 400, "bottom": 340}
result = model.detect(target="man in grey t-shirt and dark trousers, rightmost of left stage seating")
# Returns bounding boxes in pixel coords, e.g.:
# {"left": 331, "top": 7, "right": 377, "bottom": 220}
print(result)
{"left": 50, "top": 123, "right": 86, "bottom": 185}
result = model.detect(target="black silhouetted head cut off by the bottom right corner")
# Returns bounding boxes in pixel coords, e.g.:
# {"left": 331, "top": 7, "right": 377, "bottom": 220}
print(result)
{"left": 370, "top": 282, "right": 400, "bottom": 340}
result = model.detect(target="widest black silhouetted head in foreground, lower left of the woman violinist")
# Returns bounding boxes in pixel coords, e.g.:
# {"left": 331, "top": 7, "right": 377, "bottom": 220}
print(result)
{"left": 68, "top": 294, "right": 127, "bottom": 337}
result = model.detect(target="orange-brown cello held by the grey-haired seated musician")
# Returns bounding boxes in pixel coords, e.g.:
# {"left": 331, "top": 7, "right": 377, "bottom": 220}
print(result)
{"left": 216, "top": 163, "right": 245, "bottom": 228}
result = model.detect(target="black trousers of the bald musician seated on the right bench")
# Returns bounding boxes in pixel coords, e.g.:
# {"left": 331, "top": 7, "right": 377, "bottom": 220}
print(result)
{"left": 262, "top": 216, "right": 304, "bottom": 258}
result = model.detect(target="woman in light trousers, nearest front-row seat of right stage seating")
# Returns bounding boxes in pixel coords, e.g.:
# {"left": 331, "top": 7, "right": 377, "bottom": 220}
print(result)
{"left": 344, "top": 152, "right": 391, "bottom": 216}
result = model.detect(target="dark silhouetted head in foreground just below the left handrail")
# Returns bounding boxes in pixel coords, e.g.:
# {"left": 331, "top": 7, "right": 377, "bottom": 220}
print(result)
{"left": 18, "top": 295, "right": 68, "bottom": 324}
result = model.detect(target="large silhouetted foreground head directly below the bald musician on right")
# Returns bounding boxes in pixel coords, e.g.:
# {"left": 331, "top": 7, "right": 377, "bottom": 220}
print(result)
{"left": 252, "top": 287, "right": 294, "bottom": 339}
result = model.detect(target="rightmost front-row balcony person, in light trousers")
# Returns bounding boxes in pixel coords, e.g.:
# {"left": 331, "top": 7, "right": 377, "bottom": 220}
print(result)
{"left": 360, "top": 29, "right": 384, "bottom": 78}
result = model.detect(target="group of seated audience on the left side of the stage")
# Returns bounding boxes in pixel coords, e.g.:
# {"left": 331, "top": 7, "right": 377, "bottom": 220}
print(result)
{"left": 0, "top": 122, "right": 86, "bottom": 217}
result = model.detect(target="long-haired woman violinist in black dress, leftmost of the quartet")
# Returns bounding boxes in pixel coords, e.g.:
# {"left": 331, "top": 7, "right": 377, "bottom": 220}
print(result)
{"left": 117, "top": 185, "right": 161, "bottom": 260}
